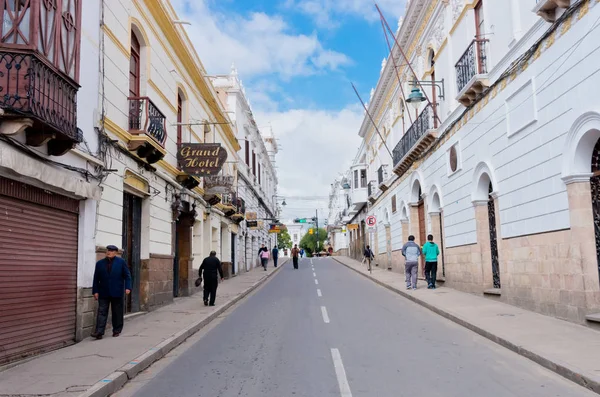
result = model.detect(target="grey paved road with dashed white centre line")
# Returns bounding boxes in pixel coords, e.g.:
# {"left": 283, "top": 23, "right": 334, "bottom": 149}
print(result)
{"left": 120, "top": 258, "right": 597, "bottom": 397}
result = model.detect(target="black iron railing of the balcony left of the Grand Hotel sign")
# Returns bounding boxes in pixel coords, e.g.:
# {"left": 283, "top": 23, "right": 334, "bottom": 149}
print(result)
{"left": 129, "top": 97, "right": 167, "bottom": 147}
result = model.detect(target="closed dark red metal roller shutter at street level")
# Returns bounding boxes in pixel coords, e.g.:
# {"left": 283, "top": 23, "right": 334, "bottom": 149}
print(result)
{"left": 0, "top": 178, "right": 78, "bottom": 363}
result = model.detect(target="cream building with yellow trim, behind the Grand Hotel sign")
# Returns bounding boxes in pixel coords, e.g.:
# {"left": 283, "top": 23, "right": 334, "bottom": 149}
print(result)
{"left": 95, "top": 0, "right": 243, "bottom": 320}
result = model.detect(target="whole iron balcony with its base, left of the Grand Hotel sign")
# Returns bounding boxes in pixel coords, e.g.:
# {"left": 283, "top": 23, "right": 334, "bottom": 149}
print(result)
{"left": 129, "top": 97, "right": 167, "bottom": 164}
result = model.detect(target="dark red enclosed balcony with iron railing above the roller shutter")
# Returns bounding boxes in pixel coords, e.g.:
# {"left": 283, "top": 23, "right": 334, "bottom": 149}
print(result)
{"left": 0, "top": 0, "right": 83, "bottom": 156}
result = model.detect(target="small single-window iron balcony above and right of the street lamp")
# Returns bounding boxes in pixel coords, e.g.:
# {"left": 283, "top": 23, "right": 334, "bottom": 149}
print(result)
{"left": 455, "top": 39, "right": 489, "bottom": 106}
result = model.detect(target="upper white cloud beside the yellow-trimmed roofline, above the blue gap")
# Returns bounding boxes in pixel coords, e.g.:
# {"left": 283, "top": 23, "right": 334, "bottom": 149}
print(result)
{"left": 173, "top": 0, "right": 351, "bottom": 79}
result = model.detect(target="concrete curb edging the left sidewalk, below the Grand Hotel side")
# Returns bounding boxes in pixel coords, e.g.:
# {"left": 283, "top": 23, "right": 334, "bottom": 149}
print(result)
{"left": 79, "top": 260, "right": 288, "bottom": 397}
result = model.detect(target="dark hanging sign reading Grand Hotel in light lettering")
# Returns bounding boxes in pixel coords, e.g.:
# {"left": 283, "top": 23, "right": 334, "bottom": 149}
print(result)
{"left": 177, "top": 143, "right": 227, "bottom": 176}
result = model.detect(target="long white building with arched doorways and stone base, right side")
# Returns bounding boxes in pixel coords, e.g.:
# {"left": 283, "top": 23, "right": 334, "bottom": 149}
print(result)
{"left": 336, "top": 0, "right": 600, "bottom": 323}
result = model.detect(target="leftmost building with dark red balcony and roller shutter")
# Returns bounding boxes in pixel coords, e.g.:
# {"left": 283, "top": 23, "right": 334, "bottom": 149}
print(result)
{"left": 0, "top": 0, "right": 106, "bottom": 365}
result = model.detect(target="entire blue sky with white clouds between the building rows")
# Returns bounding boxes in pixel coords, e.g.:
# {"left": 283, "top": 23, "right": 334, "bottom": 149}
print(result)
{"left": 173, "top": 0, "right": 405, "bottom": 219}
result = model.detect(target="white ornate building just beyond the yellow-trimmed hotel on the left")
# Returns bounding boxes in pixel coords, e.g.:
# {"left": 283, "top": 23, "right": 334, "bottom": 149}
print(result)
{"left": 212, "top": 66, "right": 279, "bottom": 271}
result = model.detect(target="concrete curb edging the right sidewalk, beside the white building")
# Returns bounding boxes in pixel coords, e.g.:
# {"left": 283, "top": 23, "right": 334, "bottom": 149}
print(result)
{"left": 332, "top": 257, "right": 600, "bottom": 394}
